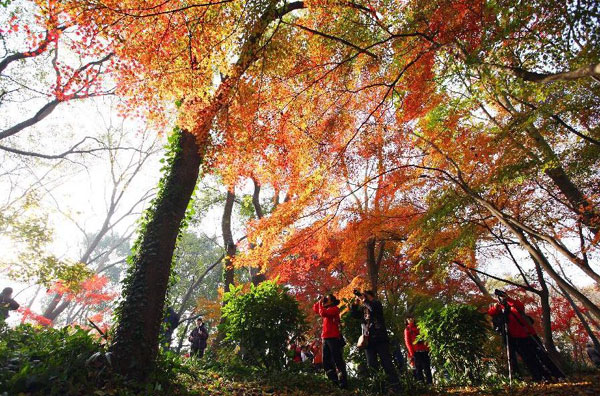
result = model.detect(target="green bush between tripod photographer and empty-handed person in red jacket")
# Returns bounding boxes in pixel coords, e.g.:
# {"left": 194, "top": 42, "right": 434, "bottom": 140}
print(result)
{"left": 419, "top": 304, "right": 488, "bottom": 383}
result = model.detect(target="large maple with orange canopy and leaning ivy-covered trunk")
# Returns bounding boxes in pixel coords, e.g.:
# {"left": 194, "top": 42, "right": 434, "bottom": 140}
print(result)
{"left": 8, "top": 0, "right": 600, "bottom": 384}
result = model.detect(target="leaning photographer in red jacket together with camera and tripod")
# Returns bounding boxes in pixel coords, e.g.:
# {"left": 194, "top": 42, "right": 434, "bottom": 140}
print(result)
{"left": 488, "top": 289, "right": 564, "bottom": 381}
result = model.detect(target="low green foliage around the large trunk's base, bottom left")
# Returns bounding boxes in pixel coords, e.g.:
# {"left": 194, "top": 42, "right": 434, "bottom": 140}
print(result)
{"left": 0, "top": 324, "right": 197, "bottom": 396}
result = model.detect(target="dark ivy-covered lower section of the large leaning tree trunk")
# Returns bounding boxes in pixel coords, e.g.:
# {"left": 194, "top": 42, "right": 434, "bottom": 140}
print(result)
{"left": 111, "top": 130, "right": 202, "bottom": 378}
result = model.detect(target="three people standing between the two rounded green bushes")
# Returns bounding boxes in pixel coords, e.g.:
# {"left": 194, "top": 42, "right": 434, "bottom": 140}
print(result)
{"left": 313, "top": 290, "right": 432, "bottom": 392}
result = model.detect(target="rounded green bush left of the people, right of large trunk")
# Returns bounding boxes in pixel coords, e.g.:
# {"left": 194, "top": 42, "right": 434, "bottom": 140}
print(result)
{"left": 220, "top": 282, "right": 306, "bottom": 370}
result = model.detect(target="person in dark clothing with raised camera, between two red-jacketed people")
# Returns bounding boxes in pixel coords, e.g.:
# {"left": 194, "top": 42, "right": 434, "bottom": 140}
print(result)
{"left": 351, "top": 290, "right": 400, "bottom": 391}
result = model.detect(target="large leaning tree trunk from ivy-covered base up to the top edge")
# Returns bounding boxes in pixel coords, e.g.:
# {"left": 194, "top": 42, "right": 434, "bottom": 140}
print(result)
{"left": 105, "top": 1, "right": 304, "bottom": 380}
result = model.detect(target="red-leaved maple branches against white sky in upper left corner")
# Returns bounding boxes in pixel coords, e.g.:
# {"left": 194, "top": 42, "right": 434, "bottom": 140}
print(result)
{"left": 0, "top": 1, "right": 116, "bottom": 145}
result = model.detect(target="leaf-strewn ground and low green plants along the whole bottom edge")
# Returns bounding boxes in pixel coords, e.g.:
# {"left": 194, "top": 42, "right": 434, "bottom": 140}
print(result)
{"left": 0, "top": 325, "right": 600, "bottom": 396}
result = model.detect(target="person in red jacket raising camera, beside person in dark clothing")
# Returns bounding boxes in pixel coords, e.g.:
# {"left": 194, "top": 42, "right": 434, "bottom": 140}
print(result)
{"left": 313, "top": 294, "right": 348, "bottom": 389}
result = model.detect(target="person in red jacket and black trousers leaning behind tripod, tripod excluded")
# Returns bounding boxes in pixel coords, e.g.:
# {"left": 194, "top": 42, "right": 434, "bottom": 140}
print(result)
{"left": 488, "top": 290, "right": 548, "bottom": 381}
